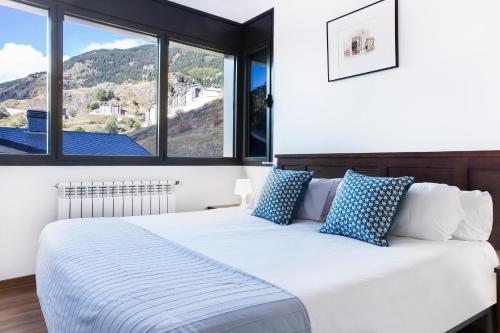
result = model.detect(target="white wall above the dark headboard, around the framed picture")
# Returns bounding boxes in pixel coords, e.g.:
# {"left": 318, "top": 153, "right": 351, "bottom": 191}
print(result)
{"left": 274, "top": 0, "right": 500, "bottom": 154}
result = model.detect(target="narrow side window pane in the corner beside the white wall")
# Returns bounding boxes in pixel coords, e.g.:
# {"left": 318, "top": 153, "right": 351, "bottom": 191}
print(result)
{"left": 246, "top": 48, "right": 272, "bottom": 161}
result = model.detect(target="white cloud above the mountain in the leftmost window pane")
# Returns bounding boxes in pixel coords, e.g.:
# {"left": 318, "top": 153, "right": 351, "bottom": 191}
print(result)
{"left": 0, "top": 43, "right": 48, "bottom": 82}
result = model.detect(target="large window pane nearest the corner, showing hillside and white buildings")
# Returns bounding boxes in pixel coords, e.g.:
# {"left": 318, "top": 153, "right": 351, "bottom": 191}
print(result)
{"left": 167, "top": 42, "right": 235, "bottom": 158}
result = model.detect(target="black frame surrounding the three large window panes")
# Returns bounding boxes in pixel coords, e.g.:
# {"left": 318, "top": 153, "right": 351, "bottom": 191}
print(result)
{"left": 0, "top": 0, "right": 242, "bottom": 166}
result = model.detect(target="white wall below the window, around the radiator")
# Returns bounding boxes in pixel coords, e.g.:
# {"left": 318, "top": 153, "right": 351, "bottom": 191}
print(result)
{"left": 0, "top": 166, "right": 243, "bottom": 281}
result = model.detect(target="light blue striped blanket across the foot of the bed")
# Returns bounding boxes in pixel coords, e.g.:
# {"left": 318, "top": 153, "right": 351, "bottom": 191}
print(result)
{"left": 36, "top": 219, "right": 310, "bottom": 333}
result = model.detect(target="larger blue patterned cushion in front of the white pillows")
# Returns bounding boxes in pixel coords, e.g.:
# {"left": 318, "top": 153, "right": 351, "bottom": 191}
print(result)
{"left": 320, "top": 170, "right": 415, "bottom": 246}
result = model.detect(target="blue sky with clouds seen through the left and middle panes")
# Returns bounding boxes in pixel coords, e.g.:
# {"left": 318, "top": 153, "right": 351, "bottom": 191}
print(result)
{"left": 0, "top": 5, "right": 151, "bottom": 83}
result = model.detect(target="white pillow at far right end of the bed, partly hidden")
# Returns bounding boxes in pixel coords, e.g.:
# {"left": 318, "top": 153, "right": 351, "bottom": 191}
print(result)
{"left": 453, "top": 191, "right": 493, "bottom": 241}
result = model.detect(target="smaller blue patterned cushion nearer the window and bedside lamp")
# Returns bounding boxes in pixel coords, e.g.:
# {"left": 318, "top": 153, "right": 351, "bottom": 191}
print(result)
{"left": 252, "top": 166, "right": 314, "bottom": 224}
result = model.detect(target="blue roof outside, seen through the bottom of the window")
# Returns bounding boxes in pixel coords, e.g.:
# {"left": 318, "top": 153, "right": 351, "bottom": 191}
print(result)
{"left": 0, "top": 127, "right": 151, "bottom": 156}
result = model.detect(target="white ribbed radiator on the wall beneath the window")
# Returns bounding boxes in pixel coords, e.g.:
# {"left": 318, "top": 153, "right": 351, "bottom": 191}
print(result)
{"left": 56, "top": 180, "right": 180, "bottom": 220}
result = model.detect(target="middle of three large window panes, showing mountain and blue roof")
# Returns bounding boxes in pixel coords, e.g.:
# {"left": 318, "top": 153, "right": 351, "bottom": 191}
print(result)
{"left": 63, "top": 17, "right": 158, "bottom": 156}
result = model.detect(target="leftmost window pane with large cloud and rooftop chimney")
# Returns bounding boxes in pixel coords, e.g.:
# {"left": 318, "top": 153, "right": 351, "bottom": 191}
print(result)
{"left": 0, "top": 0, "right": 48, "bottom": 154}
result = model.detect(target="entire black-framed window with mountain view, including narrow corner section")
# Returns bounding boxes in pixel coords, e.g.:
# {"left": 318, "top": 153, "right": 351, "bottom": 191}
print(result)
{"left": 0, "top": 0, "right": 272, "bottom": 165}
